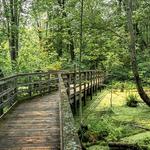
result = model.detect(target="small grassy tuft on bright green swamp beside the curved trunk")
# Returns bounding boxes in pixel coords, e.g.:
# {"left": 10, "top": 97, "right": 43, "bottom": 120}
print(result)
{"left": 126, "top": 94, "right": 138, "bottom": 107}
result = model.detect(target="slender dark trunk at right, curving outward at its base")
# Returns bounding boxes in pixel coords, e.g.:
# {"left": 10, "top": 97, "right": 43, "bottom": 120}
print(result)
{"left": 127, "top": 0, "right": 150, "bottom": 106}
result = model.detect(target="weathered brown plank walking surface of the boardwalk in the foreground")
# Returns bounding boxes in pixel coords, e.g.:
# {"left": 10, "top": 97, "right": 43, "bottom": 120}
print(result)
{"left": 0, "top": 92, "right": 60, "bottom": 150}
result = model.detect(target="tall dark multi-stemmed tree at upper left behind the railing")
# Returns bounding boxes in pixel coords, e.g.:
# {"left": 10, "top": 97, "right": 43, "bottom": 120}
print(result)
{"left": 2, "top": 0, "right": 22, "bottom": 63}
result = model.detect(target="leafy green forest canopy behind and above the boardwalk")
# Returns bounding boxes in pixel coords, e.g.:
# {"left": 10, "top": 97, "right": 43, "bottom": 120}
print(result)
{"left": 0, "top": 0, "right": 150, "bottom": 85}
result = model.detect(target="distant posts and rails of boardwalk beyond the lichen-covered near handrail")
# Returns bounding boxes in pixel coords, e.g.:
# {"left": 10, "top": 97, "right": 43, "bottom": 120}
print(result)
{"left": 62, "top": 70, "right": 105, "bottom": 113}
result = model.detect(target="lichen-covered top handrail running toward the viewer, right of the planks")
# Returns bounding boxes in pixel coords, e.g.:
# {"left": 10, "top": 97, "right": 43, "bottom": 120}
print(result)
{"left": 59, "top": 75, "right": 82, "bottom": 150}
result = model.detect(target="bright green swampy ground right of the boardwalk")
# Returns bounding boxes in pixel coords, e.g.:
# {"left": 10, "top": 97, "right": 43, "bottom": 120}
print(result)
{"left": 75, "top": 89, "right": 150, "bottom": 150}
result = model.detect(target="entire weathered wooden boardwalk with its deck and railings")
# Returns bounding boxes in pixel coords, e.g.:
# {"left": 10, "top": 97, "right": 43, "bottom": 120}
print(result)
{"left": 0, "top": 70, "right": 104, "bottom": 150}
